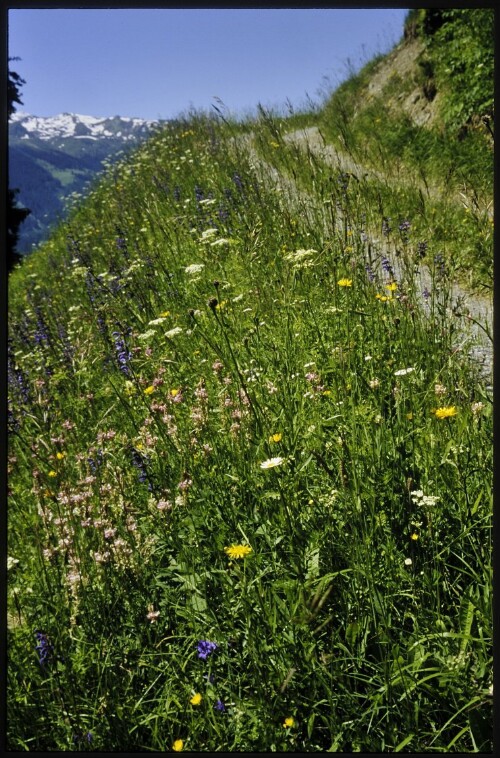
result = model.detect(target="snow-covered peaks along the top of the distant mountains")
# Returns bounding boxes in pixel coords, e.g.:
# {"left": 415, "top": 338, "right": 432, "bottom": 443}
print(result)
{"left": 9, "top": 111, "right": 158, "bottom": 140}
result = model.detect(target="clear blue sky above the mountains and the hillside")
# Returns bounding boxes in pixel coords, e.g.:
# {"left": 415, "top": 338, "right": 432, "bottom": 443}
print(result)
{"left": 8, "top": 8, "right": 407, "bottom": 119}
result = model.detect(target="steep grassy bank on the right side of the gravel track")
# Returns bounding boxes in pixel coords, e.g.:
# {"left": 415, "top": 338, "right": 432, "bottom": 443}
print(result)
{"left": 315, "top": 34, "right": 493, "bottom": 292}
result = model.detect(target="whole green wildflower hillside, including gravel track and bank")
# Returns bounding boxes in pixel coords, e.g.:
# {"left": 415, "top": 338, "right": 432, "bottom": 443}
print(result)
{"left": 6, "top": 8, "right": 494, "bottom": 753}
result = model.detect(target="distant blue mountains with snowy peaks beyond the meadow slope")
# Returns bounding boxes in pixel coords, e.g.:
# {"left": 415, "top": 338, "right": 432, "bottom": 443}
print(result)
{"left": 9, "top": 111, "right": 161, "bottom": 254}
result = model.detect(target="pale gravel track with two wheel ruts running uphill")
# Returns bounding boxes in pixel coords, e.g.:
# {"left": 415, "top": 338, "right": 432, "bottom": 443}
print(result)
{"left": 235, "top": 127, "right": 493, "bottom": 393}
